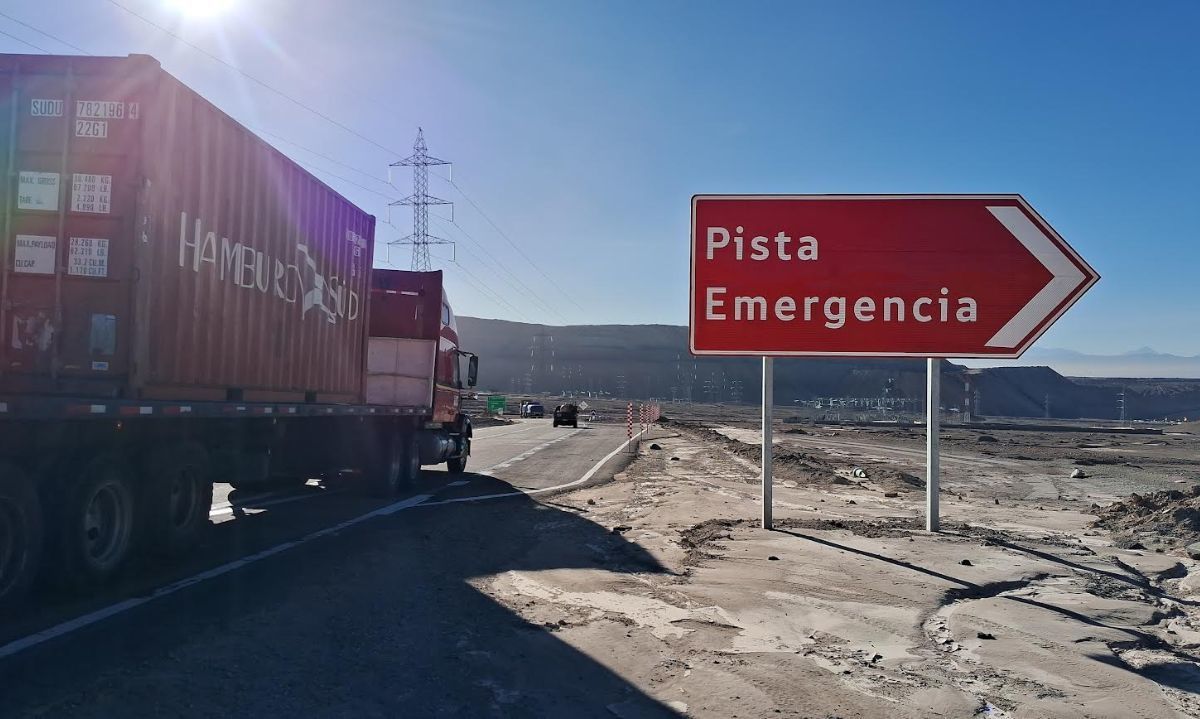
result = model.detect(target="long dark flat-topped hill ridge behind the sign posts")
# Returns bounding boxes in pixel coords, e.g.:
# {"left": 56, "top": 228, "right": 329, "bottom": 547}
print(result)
{"left": 457, "top": 317, "right": 1200, "bottom": 419}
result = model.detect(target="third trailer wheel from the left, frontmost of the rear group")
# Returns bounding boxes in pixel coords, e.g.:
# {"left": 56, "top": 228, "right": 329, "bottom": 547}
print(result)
{"left": 143, "top": 443, "right": 212, "bottom": 556}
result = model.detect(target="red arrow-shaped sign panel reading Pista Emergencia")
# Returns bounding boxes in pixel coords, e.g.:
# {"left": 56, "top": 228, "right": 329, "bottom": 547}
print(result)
{"left": 690, "top": 194, "right": 1099, "bottom": 358}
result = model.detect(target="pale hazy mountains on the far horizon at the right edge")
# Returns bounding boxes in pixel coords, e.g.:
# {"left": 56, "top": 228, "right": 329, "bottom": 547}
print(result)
{"left": 964, "top": 347, "right": 1200, "bottom": 379}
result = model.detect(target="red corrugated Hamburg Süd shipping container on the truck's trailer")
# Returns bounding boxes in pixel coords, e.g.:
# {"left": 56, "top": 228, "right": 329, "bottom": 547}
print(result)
{"left": 0, "top": 55, "right": 374, "bottom": 402}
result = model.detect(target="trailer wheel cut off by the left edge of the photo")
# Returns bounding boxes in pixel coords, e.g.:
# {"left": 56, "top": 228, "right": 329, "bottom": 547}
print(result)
{"left": 0, "top": 462, "right": 42, "bottom": 616}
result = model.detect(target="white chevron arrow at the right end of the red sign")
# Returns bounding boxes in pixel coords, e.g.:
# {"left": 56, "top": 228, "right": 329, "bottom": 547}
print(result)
{"left": 988, "top": 206, "right": 1086, "bottom": 347}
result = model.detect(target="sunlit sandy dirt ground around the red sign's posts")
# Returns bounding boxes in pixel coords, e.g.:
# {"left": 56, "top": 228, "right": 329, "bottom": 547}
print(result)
{"left": 472, "top": 423, "right": 1200, "bottom": 718}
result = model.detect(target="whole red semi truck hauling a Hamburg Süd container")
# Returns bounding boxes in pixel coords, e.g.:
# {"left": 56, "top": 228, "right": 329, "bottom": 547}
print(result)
{"left": 0, "top": 55, "right": 479, "bottom": 609}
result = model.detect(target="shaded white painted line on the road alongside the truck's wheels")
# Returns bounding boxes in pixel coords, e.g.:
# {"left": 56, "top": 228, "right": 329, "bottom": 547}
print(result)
{"left": 0, "top": 495, "right": 433, "bottom": 659}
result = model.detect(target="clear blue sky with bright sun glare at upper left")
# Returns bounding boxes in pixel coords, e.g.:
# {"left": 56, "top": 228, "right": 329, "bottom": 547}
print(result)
{"left": 0, "top": 0, "right": 1200, "bottom": 354}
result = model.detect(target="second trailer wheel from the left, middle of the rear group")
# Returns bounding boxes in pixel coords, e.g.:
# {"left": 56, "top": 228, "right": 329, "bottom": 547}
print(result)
{"left": 55, "top": 455, "right": 137, "bottom": 588}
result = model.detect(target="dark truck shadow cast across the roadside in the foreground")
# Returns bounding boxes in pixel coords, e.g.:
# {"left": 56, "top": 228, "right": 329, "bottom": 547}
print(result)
{"left": 0, "top": 473, "right": 678, "bottom": 718}
